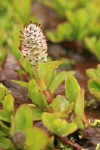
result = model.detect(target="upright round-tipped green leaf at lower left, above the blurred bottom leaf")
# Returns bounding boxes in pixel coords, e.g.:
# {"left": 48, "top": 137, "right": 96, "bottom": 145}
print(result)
{"left": 15, "top": 105, "right": 33, "bottom": 131}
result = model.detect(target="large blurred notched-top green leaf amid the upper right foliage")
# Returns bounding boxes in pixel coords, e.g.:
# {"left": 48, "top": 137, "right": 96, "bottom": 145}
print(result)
{"left": 66, "top": 8, "right": 89, "bottom": 41}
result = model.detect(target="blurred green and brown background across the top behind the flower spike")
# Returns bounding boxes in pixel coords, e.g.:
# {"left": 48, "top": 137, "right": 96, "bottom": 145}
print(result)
{"left": 0, "top": 0, "right": 100, "bottom": 62}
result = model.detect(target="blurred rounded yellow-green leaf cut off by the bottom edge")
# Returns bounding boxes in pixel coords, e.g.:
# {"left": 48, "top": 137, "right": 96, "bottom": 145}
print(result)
{"left": 25, "top": 128, "right": 48, "bottom": 150}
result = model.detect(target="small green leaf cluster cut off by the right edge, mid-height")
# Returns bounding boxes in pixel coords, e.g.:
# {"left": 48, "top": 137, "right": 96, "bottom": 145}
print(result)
{"left": 87, "top": 65, "right": 100, "bottom": 101}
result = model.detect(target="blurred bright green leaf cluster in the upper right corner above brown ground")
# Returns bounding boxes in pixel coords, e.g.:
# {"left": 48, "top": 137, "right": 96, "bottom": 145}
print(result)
{"left": 43, "top": 0, "right": 100, "bottom": 60}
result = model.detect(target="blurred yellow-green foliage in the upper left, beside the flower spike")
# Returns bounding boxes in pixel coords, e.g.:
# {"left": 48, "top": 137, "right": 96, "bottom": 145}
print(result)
{"left": 0, "top": 0, "right": 36, "bottom": 59}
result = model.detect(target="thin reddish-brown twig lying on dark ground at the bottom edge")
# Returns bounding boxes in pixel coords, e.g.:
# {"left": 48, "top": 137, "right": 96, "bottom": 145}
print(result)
{"left": 58, "top": 137, "right": 84, "bottom": 150}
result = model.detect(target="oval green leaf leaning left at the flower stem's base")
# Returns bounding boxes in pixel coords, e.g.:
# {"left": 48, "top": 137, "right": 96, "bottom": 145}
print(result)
{"left": 28, "top": 79, "right": 47, "bottom": 108}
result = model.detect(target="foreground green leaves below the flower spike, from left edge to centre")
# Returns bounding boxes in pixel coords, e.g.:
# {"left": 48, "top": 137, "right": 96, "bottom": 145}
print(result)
{"left": 0, "top": 60, "right": 87, "bottom": 150}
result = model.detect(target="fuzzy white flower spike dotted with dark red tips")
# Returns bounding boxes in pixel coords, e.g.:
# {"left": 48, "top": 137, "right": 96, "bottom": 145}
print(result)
{"left": 19, "top": 23, "right": 48, "bottom": 66}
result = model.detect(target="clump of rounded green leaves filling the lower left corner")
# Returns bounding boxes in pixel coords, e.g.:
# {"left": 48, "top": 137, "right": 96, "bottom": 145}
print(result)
{"left": 0, "top": 94, "right": 48, "bottom": 150}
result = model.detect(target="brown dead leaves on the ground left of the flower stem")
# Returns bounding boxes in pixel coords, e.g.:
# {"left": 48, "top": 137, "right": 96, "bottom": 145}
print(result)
{"left": 0, "top": 54, "right": 30, "bottom": 107}
